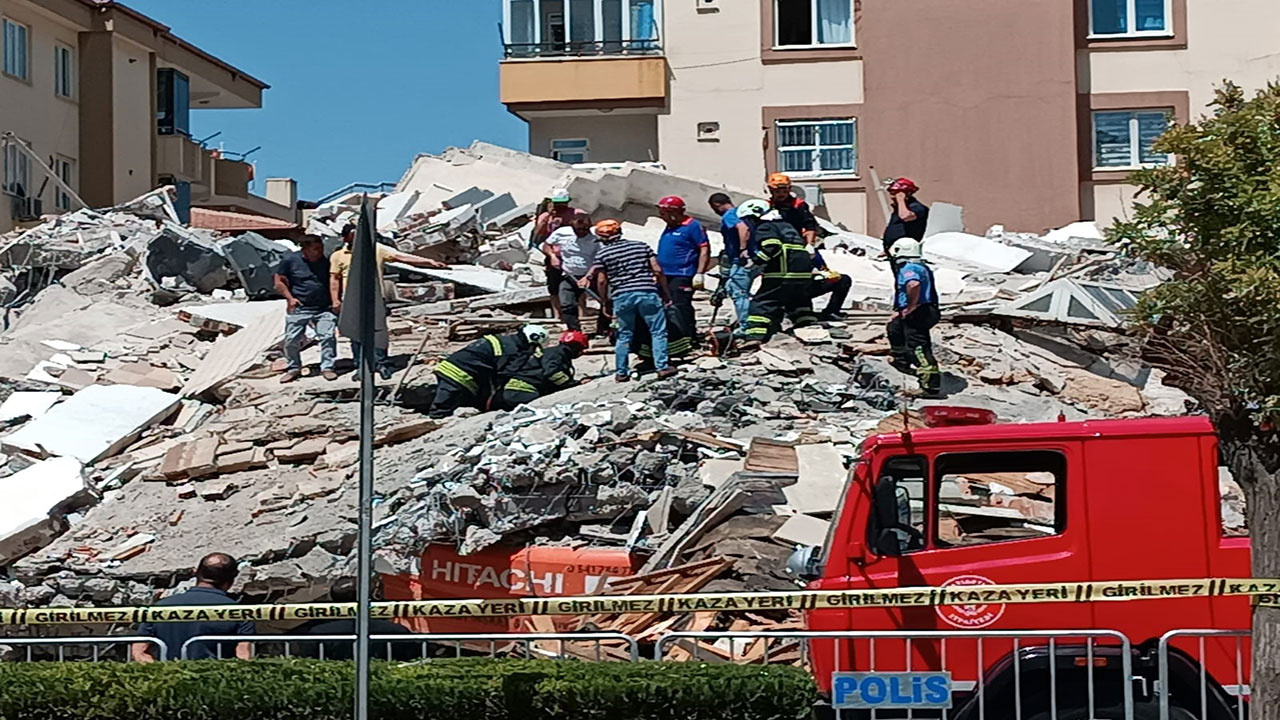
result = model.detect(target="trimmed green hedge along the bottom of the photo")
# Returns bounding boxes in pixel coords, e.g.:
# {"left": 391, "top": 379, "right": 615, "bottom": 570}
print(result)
{"left": 0, "top": 660, "right": 817, "bottom": 720}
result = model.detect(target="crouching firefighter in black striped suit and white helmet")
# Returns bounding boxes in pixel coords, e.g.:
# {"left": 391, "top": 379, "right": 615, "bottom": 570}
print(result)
{"left": 430, "top": 325, "right": 547, "bottom": 418}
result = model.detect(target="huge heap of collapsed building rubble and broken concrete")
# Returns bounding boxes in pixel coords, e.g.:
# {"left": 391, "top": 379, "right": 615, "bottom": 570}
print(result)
{"left": 0, "top": 137, "right": 1228, "bottom": 659}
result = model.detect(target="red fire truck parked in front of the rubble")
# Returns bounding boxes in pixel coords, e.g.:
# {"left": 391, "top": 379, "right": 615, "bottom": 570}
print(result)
{"left": 794, "top": 409, "right": 1251, "bottom": 720}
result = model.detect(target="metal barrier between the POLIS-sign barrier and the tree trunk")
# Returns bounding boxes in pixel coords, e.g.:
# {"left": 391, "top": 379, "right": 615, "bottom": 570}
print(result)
{"left": 1157, "top": 629, "right": 1252, "bottom": 720}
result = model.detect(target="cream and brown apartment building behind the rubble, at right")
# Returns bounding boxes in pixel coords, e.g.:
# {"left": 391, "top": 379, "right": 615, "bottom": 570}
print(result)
{"left": 500, "top": 0, "right": 1280, "bottom": 234}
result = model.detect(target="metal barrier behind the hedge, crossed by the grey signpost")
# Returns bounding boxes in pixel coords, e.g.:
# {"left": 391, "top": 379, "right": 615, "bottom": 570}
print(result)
{"left": 179, "top": 633, "right": 640, "bottom": 661}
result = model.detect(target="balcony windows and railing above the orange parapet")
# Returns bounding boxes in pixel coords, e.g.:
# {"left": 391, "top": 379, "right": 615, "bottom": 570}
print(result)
{"left": 502, "top": 0, "right": 662, "bottom": 60}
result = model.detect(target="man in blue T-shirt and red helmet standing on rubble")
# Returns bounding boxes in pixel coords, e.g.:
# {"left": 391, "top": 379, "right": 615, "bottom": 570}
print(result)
{"left": 658, "top": 196, "right": 712, "bottom": 340}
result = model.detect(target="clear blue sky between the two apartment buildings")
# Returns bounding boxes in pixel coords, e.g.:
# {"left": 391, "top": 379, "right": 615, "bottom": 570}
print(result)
{"left": 125, "top": 0, "right": 527, "bottom": 200}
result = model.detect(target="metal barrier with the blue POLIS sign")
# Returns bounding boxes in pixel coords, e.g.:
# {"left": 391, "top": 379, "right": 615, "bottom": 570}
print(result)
{"left": 653, "top": 630, "right": 1134, "bottom": 720}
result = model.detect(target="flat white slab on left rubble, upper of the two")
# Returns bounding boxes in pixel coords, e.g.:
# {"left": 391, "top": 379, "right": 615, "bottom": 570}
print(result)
{"left": 0, "top": 384, "right": 179, "bottom": 465}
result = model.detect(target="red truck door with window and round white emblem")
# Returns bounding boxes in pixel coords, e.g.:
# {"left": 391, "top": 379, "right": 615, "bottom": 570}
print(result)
{"left": 851, "top": 445, "right": 1092, "bottom": 679}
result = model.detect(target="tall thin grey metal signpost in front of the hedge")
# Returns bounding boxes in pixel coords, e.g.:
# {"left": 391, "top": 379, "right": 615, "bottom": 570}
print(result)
{"left": 352, "top": 196, "right": 380, "bottom": 720}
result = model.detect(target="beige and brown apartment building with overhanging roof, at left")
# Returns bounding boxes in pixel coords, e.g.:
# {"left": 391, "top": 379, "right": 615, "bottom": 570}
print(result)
{"left": 0, "top": 0, "right": 296, "bottom": 232}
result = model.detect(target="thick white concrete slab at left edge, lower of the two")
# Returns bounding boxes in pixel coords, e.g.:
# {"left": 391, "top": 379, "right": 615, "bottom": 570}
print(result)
{"left": 0, "top": 457, "right": 90, "bottom": 565}
